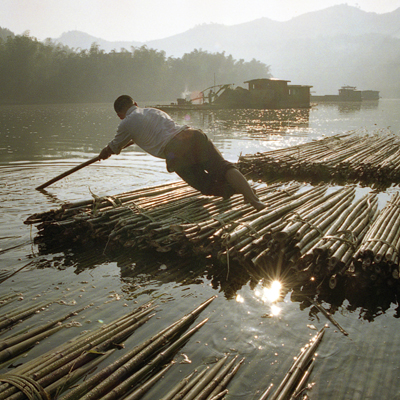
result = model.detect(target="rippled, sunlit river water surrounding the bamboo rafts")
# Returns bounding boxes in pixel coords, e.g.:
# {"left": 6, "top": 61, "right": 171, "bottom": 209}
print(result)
{"left": 0, "top": 99, "right": 400, "bottom": 400}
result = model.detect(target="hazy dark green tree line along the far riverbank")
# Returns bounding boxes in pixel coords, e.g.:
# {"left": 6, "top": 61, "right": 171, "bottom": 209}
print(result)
{"left": 0, "top": 34, "right": 271, "bottom": 104}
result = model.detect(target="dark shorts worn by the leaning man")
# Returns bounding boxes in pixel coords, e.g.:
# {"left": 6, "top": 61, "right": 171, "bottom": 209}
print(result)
{"left": 164, "top": 128, "right": 236, "bottom": 198}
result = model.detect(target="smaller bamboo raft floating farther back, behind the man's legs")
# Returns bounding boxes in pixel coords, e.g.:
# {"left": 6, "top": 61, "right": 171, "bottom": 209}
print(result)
{"left": 238, "top": 131, "right": 400, "bottom": 188}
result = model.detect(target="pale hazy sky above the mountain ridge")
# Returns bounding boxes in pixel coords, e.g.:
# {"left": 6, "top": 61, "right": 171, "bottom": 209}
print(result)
{"left": 0, "top": 0, "right": 400, "bottom": 41}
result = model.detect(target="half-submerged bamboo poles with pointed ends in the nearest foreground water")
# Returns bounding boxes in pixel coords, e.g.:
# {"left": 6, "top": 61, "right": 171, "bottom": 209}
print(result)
{"left": 0, "top": 294, "right": 325, "bottom": 400}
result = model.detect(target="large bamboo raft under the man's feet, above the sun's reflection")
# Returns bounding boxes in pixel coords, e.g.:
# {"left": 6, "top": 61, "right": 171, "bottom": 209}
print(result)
{"left": 26, "top": 177, "right": 400, "bottom": 289}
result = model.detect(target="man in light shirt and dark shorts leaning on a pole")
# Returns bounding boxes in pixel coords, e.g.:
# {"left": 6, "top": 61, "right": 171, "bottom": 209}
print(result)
{"left": 99, "top": 95, "right": 265, "bottom": 210}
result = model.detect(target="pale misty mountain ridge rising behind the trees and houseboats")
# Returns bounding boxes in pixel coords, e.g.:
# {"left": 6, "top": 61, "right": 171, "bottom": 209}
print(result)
{"left": 48, "top": 4, "right": 400, "bottom": 97}
